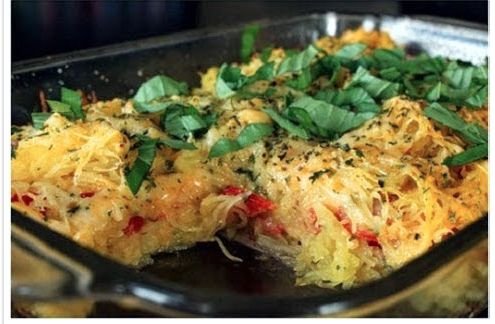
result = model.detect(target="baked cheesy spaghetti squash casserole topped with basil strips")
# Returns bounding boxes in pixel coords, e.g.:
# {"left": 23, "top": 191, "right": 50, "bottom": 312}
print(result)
{"left": 12, "top": 26, "right": 488, "bottom": 316}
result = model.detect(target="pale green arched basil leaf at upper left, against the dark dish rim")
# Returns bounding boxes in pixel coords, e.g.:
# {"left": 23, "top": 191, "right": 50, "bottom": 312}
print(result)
{"left": 134, "top": 75, "right": 189, "bottom": 103}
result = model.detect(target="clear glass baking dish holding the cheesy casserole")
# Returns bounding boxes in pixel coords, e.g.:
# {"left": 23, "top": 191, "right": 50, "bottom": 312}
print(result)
{"left": 11, "top": 13, "right": 488, "bottom": 317}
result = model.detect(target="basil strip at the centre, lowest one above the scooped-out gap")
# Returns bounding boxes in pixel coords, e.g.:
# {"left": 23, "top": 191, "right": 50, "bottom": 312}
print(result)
{"left": 208, "top": 123, "right": 273, "bottom": 158}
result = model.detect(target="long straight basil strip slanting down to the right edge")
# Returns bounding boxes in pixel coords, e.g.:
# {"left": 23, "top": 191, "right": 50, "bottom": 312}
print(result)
{"left": 423, "top": 103, "right": 488, "bottom": 144}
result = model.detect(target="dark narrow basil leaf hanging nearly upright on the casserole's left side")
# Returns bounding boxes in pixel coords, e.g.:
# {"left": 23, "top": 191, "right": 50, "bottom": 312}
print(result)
{"left": 125, "top": 139, "right": 158, "bottom": 195}
